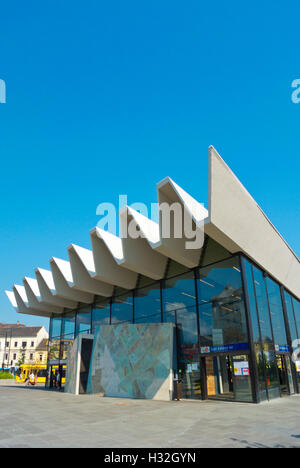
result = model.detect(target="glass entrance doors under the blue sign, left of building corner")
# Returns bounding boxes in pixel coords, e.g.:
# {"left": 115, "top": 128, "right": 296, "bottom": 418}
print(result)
{"left": 205, "top": 354, "right": 253, "bottom": 401}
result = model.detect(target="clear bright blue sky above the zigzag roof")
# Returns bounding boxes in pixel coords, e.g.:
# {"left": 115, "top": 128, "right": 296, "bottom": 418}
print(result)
{"left": 0, "top": 0, "right": 300, "bottom": 325}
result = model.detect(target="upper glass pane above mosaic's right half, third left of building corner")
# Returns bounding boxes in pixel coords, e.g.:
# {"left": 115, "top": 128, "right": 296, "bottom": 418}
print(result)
{"left": 134, "top": 282, "right": 161, "bottom": 323}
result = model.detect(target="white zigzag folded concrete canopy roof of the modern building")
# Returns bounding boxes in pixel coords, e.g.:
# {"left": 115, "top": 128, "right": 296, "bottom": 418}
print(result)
{"left": 6, "top": 146, "right": 300, "bottom": 316}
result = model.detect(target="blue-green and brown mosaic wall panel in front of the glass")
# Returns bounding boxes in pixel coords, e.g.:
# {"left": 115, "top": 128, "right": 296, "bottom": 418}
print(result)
{"left": 88, "top": 323, "right": 174, "bottom": 399}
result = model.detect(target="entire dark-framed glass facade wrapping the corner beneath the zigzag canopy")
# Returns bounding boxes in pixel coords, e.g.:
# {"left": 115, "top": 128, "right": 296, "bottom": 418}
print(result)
{"left": 49, "top": 239, "right": 300, "bottom": 402}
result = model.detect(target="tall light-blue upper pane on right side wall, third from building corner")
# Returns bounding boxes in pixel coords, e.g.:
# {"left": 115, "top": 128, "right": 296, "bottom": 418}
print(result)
{"left": 266, "top": 278, "right": 287, "bottom": 346}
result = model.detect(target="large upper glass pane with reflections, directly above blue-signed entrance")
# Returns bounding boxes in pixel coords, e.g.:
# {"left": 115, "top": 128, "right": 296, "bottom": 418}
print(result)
{"left": 197, "top": 257, "right": 248, "bottom": 346}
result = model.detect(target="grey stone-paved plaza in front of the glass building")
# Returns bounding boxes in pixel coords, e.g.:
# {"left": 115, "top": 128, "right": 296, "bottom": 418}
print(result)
{"left": 0, "top": 385, "right": 300, "bottom": 448}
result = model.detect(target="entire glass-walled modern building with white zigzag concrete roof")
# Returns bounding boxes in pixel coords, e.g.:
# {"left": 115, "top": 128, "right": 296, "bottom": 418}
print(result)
{"left": 7, "top": 147, "right": 300, "bottom": 403}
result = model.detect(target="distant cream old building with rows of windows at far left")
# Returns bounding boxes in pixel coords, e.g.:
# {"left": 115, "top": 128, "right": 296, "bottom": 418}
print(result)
{"left": 0, "top": 324, "right": 49, "bottom": 369}
